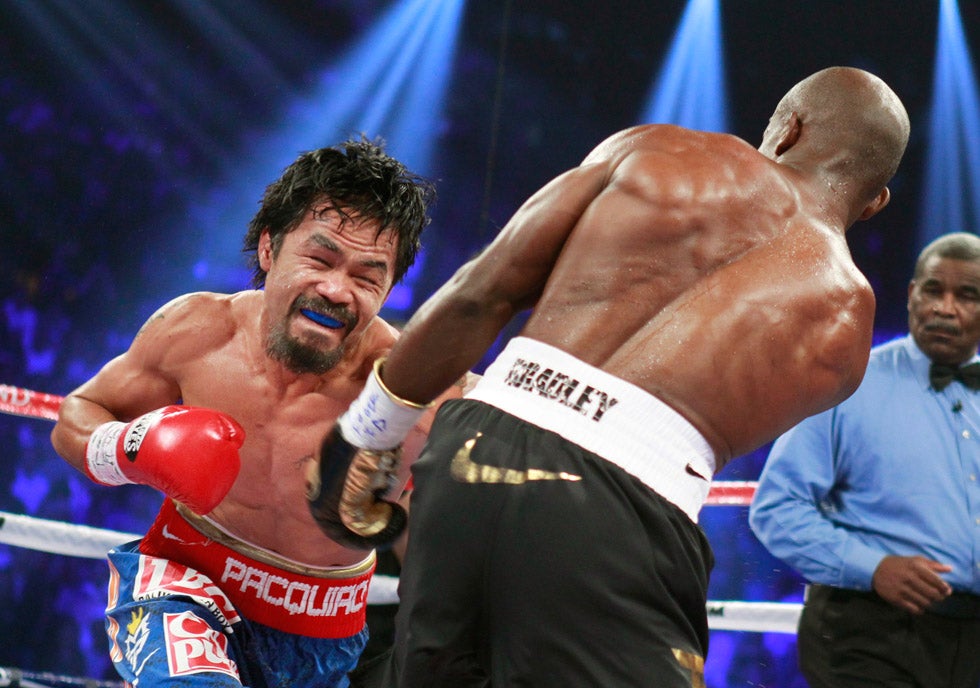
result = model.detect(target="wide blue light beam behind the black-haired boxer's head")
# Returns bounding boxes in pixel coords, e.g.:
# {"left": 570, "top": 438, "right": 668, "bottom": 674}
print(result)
{"left": 185, "top": 0, "right": 464, "bottom": 311}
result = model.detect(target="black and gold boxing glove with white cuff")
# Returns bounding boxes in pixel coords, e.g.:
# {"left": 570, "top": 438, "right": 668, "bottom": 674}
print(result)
{"left": 306, "top": 358, "right": 431, "bottom": 549}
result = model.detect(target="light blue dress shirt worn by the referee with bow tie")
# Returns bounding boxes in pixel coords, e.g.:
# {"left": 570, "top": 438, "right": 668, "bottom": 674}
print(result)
{"left": 749, "top": 336, "right": 980, "bottom": 594}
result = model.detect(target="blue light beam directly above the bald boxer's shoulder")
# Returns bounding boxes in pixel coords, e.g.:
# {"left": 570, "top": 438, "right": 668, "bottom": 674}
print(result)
{"left": 640, "top": 0, "right": 729, "bottom": 132}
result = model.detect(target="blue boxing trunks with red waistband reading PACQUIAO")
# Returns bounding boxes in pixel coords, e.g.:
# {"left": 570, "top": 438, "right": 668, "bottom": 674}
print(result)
{"left": 106, "top": 499, "right": 375, "bottom": 688}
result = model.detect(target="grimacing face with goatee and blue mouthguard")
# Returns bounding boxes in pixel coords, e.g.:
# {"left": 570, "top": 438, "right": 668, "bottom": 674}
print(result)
{"left": 259, "top": 210, "right": 397, "bottom": 375}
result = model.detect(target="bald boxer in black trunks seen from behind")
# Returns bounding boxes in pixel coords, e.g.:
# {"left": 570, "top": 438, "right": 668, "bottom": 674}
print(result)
{"left": 314, "top": 67, "right": 909, "bottom": 688}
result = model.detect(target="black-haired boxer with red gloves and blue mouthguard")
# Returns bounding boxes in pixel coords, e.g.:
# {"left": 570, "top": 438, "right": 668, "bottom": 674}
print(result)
{"left": 45, "top": 140, "right": 460, "bottom": 688}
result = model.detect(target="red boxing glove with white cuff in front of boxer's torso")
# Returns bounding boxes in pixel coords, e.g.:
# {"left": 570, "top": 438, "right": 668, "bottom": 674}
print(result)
{"left": 85, "top": 406, "right": 245, "bottom": 514}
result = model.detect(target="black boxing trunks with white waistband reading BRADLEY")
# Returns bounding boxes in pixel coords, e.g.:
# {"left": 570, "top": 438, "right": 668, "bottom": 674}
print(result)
{"left": 374, "top": 338, "right": 713, "bottom": 688}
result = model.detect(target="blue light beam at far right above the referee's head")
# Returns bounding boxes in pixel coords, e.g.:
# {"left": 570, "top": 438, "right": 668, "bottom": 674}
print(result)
{"left": 919, "top": 0, "right": 980, "bottom": 247}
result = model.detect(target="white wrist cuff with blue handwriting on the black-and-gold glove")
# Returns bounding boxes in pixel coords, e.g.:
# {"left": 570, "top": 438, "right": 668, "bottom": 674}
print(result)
{"left": 337, "top": 359, "right": 431, "bottom": 451}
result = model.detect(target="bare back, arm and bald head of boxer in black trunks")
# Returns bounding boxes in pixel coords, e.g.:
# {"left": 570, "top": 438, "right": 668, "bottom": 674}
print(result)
{"left": 382, "top": 69, "right": 908, "bottom": 470}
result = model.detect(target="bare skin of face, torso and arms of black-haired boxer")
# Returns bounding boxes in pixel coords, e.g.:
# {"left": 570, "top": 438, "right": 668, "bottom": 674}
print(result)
{"left": 52, "top": 213, "right": 460, "bottom": 566}
